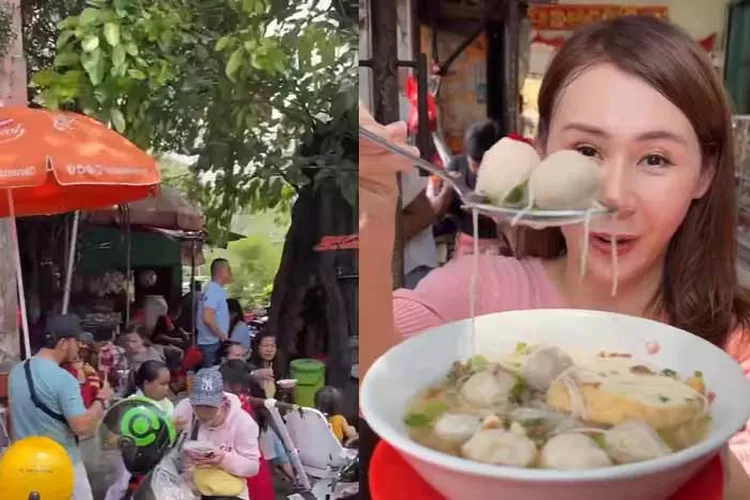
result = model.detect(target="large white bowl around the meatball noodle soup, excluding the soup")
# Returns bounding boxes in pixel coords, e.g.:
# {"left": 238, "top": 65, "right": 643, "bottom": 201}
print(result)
{"left": 361, "top": 309, "right": 750, "bottom": 500}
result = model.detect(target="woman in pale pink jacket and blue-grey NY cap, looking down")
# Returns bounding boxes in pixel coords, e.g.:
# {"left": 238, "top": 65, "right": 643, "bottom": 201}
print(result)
{"left": 174, "top": 368, "right": 260, "bottom": 500}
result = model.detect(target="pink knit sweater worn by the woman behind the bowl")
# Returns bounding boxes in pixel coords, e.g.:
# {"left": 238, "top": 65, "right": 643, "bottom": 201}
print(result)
{"left": 393, "top": 255, "right": 750, "bottom": 473}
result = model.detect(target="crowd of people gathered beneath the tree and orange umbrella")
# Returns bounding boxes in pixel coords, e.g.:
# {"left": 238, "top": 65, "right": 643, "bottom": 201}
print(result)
{"left": 2, "top": 259, "right": 356, "bottom": 500}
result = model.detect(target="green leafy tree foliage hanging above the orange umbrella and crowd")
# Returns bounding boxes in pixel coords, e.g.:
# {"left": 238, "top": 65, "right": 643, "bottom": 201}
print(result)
{"left": 25, "top": 0, "right": 357, "bottom": 241}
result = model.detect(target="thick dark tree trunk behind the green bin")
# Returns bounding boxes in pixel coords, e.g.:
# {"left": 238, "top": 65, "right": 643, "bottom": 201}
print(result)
{"left": 267, "top": 180, "right": 358, "bottom": 414}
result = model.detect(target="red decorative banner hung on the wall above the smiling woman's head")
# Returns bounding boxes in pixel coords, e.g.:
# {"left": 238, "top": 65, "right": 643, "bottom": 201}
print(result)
{"left": 529, "top": 5, "right": 669, "bottom": 31}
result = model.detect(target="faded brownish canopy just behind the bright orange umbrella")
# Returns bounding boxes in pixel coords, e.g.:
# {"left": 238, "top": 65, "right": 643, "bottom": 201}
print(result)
{"left": 87, "top": 186, "right": 205, "bottom": 231}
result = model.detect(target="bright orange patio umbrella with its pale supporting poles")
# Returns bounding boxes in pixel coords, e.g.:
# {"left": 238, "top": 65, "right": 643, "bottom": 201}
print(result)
{"left": 0, "top": 107, "right": 160, "bottom": 355}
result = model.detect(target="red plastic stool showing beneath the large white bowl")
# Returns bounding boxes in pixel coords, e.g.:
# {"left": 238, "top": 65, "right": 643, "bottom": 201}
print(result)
{"left": 370, "top": 441, "right": 724, "bottom": 500}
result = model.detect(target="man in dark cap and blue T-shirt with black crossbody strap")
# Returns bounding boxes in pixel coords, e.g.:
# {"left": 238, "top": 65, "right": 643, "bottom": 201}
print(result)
{"left": 8, "top": 314, "right": 112, "bottom": 500}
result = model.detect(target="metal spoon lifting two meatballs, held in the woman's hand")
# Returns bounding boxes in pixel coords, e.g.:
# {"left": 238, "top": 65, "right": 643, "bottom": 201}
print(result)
{"left": 359, "top": 127, "right": 614, "bottom": 229}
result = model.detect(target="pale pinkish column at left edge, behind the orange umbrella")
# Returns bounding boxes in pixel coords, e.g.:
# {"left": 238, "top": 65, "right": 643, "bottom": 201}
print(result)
{"left": 0, "top": 0, "right": 27, "bottom": 372}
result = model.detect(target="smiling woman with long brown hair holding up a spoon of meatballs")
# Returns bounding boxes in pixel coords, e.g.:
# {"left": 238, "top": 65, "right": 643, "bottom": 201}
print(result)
{"left": 360, "top": 17, "right": 750, "bottom": 498}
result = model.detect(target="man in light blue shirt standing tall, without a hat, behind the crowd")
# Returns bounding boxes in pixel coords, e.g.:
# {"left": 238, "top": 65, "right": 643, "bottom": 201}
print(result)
{"left": 196, "top": 259, "right": 232, "bottom": 367}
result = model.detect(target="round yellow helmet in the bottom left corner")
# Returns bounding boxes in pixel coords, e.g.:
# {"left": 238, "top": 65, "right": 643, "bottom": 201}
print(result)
{"left": 0, "top": 436, "right": 75, "bottom": 500}
